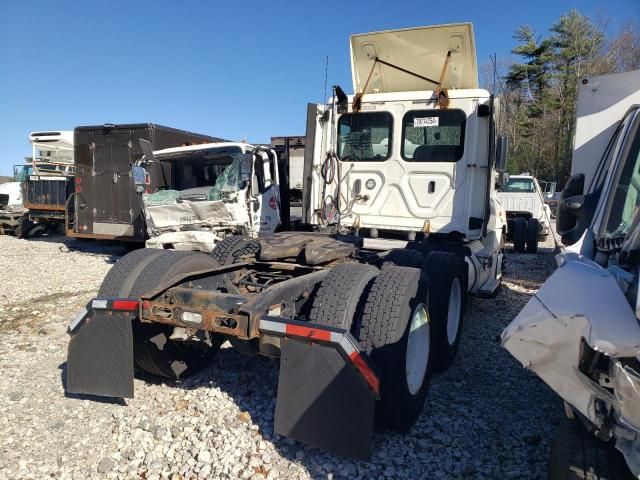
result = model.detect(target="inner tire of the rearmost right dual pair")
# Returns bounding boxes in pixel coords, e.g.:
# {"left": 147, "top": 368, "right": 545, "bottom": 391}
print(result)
{"left": 309, "top": 263, "right": 379, "bottom": 330}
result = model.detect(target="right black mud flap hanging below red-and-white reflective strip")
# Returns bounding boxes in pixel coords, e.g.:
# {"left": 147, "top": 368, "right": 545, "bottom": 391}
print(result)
{"left": 275, "top": 338, "right": 376, "bottom": 460}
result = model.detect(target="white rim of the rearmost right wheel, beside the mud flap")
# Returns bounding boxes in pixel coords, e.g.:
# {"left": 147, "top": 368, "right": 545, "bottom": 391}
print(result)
{"left": 405, "top": 303, "right": 431, "bottom": 395}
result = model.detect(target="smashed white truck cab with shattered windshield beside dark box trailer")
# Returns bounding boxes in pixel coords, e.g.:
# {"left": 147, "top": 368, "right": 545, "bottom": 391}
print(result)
{"left": 134, "top": 142, "right": 280, "bottom": 253}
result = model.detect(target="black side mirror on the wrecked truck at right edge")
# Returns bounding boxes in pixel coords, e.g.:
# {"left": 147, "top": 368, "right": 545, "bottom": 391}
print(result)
{"left": 556, "top": 173, "right": 600, "bottom": 245}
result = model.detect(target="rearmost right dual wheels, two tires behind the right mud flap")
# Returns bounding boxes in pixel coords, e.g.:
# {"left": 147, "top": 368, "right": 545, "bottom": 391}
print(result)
{"left": 309, "top": 263, "right": 432, "bottom": 430}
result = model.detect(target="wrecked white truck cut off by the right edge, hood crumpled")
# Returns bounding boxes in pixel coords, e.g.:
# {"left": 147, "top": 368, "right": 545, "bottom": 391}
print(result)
{"left": 502, "top": 70, "right": 640, "bottom": 480}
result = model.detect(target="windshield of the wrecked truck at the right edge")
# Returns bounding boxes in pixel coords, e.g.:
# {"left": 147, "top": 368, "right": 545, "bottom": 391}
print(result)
{"left": 604, "top": 128, "right": 640, "bottom": 238}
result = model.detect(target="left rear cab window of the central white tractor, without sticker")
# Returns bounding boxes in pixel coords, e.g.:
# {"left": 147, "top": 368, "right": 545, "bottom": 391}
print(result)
{"left": 338, "top": 112, "right": 393, "bottom": 162}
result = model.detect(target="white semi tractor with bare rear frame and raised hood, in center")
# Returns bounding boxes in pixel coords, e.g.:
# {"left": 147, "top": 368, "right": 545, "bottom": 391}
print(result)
{"left": 66, "top": 23, "right": 506, "bottom": 458}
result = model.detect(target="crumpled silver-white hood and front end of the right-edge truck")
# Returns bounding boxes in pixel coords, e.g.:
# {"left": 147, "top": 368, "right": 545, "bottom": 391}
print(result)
{"left": 502, "top": 253, "right": 640, "bottom": 473}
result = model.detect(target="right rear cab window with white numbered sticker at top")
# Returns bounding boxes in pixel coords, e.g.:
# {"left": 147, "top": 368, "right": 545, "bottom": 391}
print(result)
{"left": 402, "top": 109, "right": 467, "bottom": 162}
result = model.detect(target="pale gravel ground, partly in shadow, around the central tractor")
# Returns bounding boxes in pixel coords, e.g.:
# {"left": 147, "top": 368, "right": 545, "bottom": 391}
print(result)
{"left": 0, "top": 236, "right": 561, "bottom": 480}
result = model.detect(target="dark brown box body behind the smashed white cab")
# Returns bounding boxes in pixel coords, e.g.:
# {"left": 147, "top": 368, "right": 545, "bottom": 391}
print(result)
{"left": 66, "top": 123, "right": 222, "bottom": 242}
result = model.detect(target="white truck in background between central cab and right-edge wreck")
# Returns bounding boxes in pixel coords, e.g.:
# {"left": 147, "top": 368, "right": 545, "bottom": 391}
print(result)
{"left": 498, "top": 173, "right": 551, "bottom": 253}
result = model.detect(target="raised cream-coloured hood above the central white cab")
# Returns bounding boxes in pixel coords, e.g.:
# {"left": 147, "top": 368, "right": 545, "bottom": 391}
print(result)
{"left": 350, "top": 23, "right": 478, "bottom": 93}
